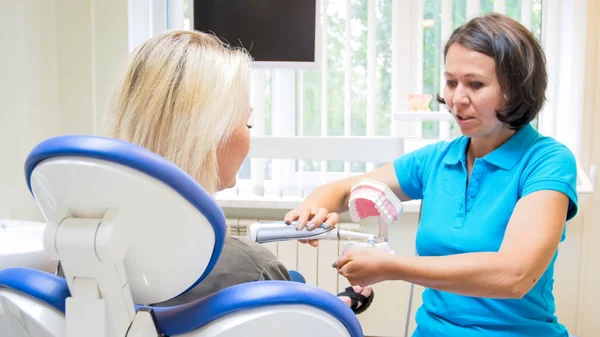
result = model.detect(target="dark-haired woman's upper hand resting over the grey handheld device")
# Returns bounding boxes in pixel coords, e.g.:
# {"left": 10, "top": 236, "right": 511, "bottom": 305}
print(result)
{"left": 284, "top": 206, "right": 340, "bottom": 247}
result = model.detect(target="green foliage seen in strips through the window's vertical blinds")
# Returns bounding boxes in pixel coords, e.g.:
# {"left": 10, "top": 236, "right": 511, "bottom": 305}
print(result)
{"left": 288, "top": 0, "right": 542, "bottom": 161}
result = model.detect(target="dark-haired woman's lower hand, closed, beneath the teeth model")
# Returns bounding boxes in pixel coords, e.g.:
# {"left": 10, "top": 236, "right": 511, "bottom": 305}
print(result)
{"left": 337, "top": 248, "right": 394, "bottom": 287}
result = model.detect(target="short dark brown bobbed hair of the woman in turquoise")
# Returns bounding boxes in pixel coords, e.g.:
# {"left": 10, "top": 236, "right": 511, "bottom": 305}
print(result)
{"left": 437, "top": 13, "right": 548, "bottom": 129}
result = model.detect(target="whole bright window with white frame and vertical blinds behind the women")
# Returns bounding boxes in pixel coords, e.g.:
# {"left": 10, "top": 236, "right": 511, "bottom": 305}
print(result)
{"left": 130, "top": 0, "right": 587, "bottom": 208}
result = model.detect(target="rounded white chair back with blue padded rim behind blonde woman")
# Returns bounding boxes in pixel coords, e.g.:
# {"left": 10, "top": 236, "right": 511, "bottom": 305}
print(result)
{"left": 25, "top": 135, "right": 225, "bottom": 304}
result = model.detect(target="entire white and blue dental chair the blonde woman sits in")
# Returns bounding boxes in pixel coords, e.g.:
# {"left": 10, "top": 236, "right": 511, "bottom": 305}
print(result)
{"left": 0, "top": 136, "right": 363, "bottom": 337}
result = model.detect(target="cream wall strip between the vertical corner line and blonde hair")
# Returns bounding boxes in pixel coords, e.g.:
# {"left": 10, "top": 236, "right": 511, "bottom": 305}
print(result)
{"left": 55, "top": 0, "right": 129, "bottom": 135}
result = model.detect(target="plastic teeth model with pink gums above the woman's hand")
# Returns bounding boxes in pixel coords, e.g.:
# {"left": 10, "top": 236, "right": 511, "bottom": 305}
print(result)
{"left": 348, "top": 179, "right": 403, "bottom": 241}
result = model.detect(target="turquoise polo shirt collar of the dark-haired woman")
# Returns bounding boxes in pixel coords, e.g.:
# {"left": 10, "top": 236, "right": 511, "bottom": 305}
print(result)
{"left": 444, "top": 124, "right": 539, "bottom": 170}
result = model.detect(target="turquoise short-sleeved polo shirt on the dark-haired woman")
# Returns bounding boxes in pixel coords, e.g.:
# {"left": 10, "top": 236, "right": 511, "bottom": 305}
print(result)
{"left": 394, "top": 125, "right": 577, "bottom": 337}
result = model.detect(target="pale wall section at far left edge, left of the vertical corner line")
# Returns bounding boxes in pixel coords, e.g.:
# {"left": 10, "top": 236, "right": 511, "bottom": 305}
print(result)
{"left": 0, "top": 0, "right": 59, "bottom": 218}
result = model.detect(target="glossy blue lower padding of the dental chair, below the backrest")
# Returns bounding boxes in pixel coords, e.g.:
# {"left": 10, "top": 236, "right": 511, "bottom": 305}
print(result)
{"left": 0, "top": 268, "right": 363, "bottom": 337}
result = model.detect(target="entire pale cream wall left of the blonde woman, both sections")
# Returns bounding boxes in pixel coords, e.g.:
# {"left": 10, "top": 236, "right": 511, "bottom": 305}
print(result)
{"left": 0, "top": 0, "right": 128, "bottom": 220}
